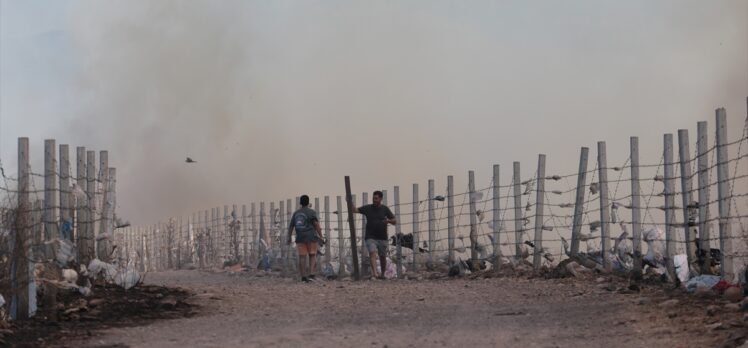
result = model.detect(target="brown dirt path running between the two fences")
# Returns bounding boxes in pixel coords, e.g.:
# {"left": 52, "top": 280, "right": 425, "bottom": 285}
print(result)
{"left": 79, "top": 271, "right": 745, "bottom": 347}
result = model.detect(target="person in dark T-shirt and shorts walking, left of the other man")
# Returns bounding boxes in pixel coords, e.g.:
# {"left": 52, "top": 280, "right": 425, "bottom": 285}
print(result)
{"left": 288, "top": 195, "right": 324, "bottom": 282}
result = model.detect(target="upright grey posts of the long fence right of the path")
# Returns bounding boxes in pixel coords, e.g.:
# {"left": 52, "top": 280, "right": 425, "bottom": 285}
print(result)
{"left": 120, "top": 104, "right": 733, "bottom": 277}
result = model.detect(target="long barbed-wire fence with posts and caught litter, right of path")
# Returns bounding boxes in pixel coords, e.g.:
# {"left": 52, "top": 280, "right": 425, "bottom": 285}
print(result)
{"left": 115, "top": 102, "right": 748, "bottom": 279}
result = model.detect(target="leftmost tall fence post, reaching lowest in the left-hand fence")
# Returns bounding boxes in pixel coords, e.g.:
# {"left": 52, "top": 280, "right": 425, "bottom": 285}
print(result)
{"left": 11, "top": 138, "right": 33, "bottom": 320}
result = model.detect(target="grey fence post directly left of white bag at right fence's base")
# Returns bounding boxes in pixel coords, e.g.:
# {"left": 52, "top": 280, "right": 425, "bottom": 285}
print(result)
{"left": 663, "top": 133, "right": 677, "bottom": 281}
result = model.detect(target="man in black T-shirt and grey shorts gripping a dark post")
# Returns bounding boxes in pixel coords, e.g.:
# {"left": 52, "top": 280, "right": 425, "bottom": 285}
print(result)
{"left": 354, "top": 191, "right": 397, "bottom": 279}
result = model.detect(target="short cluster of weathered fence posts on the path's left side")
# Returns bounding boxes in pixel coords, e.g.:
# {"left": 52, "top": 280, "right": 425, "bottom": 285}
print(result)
{"left": 3, "top": 137, "right": 117, "bottom": 319}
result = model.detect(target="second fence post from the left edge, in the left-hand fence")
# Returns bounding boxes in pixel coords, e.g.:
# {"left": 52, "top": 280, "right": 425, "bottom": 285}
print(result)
{"left": 44, "top": 139, "right": 60, "bottom": 242}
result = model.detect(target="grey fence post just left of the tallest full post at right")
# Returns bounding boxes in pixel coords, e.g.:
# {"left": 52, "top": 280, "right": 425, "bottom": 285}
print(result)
{"left": 696, "top": 121, "right": 712, "bottom": 274}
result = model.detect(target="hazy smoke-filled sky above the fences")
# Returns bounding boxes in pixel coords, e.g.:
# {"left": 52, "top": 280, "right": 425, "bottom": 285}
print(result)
{"left": 0, "top": 0, "right": 748, "bottom": 223}
